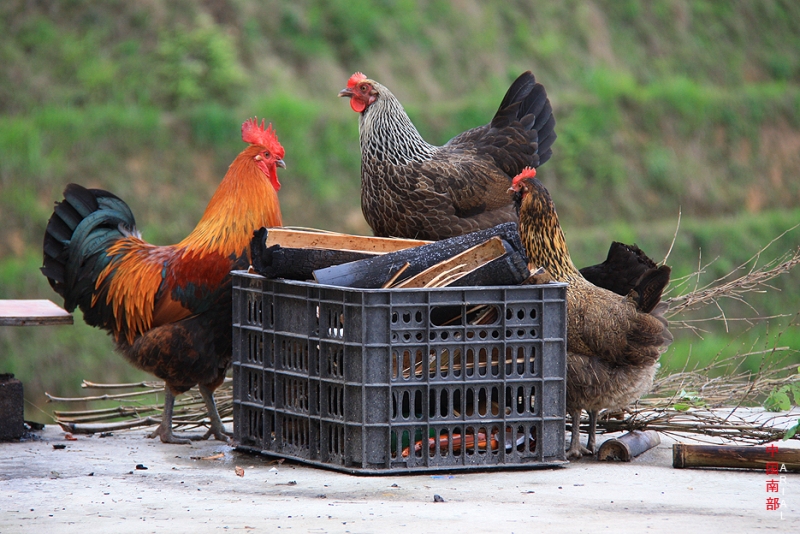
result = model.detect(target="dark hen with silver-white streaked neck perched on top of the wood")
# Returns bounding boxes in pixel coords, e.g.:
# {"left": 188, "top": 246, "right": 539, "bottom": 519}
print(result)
{"left": 339, "top": 72, "right": 556, "bottom": 240}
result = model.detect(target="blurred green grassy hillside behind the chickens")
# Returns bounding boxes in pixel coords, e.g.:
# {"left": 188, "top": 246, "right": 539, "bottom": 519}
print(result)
{"left": 0, "top": 0, "right": 800, "bottom": 422}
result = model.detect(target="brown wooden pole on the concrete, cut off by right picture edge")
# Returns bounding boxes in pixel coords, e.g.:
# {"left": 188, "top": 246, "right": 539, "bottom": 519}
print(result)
{"left": 672, "top": 443, "right": 800, "bottom": 473}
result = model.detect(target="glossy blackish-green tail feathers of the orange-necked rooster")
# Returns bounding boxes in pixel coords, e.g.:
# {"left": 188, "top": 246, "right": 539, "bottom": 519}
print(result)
{"left": 42, "top": 184, "right": 136, "bottom": 326}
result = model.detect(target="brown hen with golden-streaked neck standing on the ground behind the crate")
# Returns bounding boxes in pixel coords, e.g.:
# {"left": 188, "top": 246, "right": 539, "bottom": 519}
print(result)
{"left": 509, "top": 168, "right": 672, "bottom": 459}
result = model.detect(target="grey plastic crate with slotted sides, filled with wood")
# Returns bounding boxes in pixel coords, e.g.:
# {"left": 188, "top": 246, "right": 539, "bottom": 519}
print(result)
{"left": 233, "top": 271, "right": 566, "bottom": 474}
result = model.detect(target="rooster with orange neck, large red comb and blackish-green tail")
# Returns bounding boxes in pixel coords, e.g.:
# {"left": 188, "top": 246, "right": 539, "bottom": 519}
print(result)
{"left": 42, "top": 119, "right": 285, "bottom": 443}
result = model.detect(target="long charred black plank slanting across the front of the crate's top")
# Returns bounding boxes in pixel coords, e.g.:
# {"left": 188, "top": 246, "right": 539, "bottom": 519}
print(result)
{"left": 314, "top": 223, "right": 525, "bottom": 289}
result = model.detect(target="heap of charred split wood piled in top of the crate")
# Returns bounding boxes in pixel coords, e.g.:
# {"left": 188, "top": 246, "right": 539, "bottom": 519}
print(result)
{"left": 249, "top": 223, "right": 528, "bottom": 289}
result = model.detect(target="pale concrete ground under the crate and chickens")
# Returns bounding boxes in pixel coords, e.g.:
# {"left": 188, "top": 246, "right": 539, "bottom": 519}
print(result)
{"left": 0, "top": 426, "right": 800, "bottom": 534}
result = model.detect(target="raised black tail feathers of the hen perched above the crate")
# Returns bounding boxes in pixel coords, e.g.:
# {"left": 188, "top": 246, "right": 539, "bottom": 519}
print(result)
{"left": 491, "top": 71, "right": 556, "bottom": 167}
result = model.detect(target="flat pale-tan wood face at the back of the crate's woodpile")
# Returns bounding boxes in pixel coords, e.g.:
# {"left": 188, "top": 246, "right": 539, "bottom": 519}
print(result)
{"left": 267, "top": 228, "right": 431, "bottom": 254}
